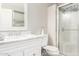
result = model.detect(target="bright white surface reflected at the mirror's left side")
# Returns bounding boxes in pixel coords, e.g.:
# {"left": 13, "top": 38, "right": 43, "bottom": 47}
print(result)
{"left": 0, "top": 9, "right": 12, "bottom": 31}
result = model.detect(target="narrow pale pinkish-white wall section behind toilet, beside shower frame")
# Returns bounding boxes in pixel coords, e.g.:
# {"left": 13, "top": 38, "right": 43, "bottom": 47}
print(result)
{"left": 48, "top": 4, "right": 57, "bottom": 46}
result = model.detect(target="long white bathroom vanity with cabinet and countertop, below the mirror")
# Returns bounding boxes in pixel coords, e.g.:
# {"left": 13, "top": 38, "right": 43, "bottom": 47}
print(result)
{"left": 0, "top": 35, "right": 47, "bottom": 56}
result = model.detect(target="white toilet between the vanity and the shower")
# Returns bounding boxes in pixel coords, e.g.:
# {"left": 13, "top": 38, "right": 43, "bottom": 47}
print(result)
{"left": 43, "top": 46, "right": 62, "bottom": 56}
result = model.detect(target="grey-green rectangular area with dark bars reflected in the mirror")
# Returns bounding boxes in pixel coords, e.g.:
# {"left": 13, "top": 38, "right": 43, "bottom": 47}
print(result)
{"left": 12, "top": 10, "right": 24, "bottom": 27}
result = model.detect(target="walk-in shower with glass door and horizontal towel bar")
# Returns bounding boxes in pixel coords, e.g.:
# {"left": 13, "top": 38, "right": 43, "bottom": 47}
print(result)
{"left": 58, "top": 3, "right": 79, "bottom": 56}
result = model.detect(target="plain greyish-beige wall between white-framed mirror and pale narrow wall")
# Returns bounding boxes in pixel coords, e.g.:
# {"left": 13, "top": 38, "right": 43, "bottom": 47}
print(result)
{"left": 28, "top": 3, "right": 47, "bottom": 34}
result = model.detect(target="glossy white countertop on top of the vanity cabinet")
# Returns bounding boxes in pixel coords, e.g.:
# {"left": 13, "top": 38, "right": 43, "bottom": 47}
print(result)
{"left": 0, "top": 35, "right": 46, "bottom": 43}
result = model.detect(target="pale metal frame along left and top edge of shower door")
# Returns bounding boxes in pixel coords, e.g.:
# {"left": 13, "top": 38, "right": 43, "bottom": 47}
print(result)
{"left": 56, "top": 3, "right": 71, "bottom": 54}
